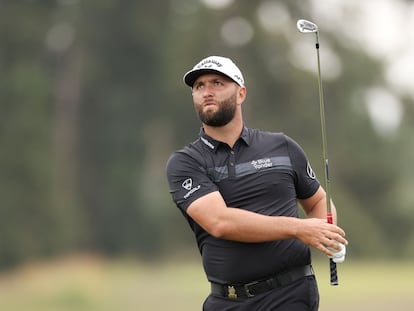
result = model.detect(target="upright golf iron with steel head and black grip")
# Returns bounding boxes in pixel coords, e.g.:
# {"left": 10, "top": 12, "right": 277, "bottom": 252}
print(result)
{"left": 296, "top": 19, "right": 338, "bottom": 285}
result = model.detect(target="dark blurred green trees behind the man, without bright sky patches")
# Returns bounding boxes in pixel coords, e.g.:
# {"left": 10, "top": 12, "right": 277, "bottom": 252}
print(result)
{"left": 0, "top": 0, "right": 414, "bottom": 267}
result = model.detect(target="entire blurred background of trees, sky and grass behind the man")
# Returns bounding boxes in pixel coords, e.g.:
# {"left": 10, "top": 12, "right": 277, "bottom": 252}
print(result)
{"left": 0, "top": 0, "right": 414, "bottom": 310}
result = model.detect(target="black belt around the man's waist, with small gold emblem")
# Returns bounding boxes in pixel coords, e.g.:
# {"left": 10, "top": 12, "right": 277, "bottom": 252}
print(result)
{"left": 211, "top": 265, "right": 314, "bottom": 298}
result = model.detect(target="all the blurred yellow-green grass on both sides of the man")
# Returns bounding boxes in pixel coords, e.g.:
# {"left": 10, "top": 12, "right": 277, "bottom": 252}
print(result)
{"left": 0, "top": 256, "right": 414, "bottom": 311}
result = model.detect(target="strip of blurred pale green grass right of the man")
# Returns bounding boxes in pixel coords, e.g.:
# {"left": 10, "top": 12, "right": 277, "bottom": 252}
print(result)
{"left": 315, "top": 260, "right": 414, "bottom": 311}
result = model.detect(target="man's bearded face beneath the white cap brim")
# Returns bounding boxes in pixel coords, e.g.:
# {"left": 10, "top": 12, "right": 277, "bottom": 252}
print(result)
{"left": 193, "top": 74, "right": 240, "bottom": 127}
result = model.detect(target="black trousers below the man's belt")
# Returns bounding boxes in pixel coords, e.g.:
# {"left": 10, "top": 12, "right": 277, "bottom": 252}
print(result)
{"left": 203, "top": 276, "right": 319, "bottom": 311}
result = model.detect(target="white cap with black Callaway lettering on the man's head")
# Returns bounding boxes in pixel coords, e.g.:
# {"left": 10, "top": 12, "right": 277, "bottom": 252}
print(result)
{"left": 183, "top": 56, "right": 244, "bottom": 87}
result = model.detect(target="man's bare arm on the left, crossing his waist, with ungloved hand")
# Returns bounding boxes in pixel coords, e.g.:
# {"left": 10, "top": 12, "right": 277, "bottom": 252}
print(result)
{"left": 187, "top": 191, "right": 347, "bottom": 256}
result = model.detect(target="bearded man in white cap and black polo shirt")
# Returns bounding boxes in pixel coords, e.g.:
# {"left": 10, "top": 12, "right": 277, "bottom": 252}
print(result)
{"left": 167, "top": 56, "right": 348, "bottom": 311}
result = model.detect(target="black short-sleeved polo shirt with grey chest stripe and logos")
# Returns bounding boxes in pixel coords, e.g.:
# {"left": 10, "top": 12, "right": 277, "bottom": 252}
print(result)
{"left": 167, "top": 128, "right": 319, "bottom": 284}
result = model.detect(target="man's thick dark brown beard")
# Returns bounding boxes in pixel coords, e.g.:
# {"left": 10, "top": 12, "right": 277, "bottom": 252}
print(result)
{"left": 197, "top": 94, "right": 237, "bottom": 127}
